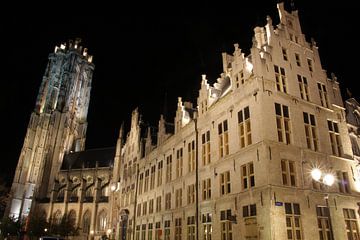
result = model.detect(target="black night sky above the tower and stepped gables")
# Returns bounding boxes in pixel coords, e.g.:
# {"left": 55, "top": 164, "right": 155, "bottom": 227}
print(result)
{"left": 0, "top": 0, "right": 359, "bottom": 186}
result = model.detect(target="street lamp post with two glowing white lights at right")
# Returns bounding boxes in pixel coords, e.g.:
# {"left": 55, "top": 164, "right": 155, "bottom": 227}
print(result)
{"left": 311, "top": 168, "right": 335, "bottom": 240}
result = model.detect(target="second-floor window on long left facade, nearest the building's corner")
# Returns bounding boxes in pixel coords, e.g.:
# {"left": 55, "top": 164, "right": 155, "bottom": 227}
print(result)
{"left": 238, "top": 107, "right": 252, "bottom": 148}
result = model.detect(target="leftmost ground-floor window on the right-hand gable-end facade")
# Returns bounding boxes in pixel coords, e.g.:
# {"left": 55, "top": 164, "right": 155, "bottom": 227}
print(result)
{"left": 285, "top": 203, "right": 302, "bottom": 240}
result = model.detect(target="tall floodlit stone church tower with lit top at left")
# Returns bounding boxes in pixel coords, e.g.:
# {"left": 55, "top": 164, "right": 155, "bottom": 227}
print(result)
{"left": 8, "top": 39, "right": 94, "bottom": 218}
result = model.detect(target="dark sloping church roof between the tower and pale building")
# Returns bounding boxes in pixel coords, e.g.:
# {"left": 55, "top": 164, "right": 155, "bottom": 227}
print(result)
{"left": 61, "top": 147, "right": 115, "bottom": 170}
